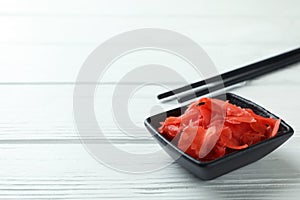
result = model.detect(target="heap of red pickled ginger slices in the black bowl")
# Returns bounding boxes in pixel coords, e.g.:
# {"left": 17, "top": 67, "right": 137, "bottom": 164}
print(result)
{"left": 159, "top": 98, "right": 281, "bottom": 161}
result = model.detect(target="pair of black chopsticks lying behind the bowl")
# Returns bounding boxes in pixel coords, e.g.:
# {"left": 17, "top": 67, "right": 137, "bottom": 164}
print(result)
{"left": 157, "top": 48, "right": 300, "bottom": 103}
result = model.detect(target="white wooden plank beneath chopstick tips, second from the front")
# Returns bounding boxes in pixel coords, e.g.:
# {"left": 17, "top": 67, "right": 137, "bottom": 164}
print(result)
{"left": 0, "top": 82, "right": 300, "bottom": 143}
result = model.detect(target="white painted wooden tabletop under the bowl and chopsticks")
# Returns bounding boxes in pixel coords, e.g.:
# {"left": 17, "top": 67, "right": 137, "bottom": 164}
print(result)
{"left": 0, "top": 0, "right": 300, "bottom": 199}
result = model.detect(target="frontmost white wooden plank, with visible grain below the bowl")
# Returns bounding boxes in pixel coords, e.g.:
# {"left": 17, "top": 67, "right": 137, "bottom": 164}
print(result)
{"left": 0, "top": 142, "right": 300, "bottom": 199}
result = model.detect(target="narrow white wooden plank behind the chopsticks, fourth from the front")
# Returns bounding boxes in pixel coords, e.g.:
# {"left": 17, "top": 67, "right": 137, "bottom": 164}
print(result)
{"left": 0, "top": 16, "right": 300, "bottom": 45}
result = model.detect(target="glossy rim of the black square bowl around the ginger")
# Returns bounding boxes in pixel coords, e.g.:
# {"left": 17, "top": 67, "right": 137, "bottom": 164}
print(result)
{"left": 144, "top": 92, "right": 294, "bottom": 166}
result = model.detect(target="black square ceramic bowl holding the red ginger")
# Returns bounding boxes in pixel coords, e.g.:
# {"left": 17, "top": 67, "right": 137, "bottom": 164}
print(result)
{"left": 144, "top": 93, "right": 294, "bottom": 180}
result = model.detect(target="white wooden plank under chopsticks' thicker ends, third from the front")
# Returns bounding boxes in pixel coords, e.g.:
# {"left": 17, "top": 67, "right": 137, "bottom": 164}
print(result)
{"left": 0, "top": 44, "right": 299, "bottom": 85}
